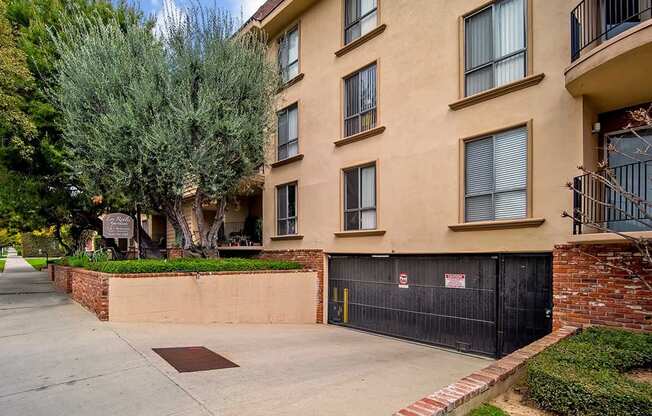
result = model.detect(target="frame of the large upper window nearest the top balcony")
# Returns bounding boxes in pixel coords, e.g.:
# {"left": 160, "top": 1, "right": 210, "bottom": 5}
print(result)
{"left": 464, "top": 0, "right": 530, "bottom": 97}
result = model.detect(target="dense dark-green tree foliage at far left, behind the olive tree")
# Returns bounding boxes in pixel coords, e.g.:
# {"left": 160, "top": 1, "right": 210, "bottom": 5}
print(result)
{"left": 0, "top": 0, "right": 143, "bottom": 254}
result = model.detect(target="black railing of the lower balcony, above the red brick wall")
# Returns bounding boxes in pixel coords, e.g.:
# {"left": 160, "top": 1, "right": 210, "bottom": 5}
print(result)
{"left": 573, "top": 161, "right": 652, "bottom": 234}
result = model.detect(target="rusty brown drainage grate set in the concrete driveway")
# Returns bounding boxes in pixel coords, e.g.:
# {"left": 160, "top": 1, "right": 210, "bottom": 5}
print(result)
{"left": 152, "top": 347, "right": 239, "bottom": 373}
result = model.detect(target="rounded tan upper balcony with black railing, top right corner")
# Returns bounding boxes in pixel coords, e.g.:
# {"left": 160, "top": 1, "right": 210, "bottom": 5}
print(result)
{"left": 565, "top": 0, "right": 652, "bottom": 112}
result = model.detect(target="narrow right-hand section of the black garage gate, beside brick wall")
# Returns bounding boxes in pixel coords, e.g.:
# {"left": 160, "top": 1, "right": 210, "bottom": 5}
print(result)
{"left": 498, "top": 254, "right": 552, "bottom": 355}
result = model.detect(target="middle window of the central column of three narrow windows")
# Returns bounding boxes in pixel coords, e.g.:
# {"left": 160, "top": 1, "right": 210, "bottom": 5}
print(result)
{"left": 344, "top": 64, "right": 376, "bottom": 137}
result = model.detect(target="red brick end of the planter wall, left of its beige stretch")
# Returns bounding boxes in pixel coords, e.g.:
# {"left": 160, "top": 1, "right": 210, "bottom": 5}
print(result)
{"left": 70, "top": 269, "right": 109, "bottom": 321}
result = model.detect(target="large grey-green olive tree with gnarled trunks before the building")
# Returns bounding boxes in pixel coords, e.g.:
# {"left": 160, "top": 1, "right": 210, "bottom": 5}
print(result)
{"left": 52, "top": 8, "right": 278, "bottom": 255}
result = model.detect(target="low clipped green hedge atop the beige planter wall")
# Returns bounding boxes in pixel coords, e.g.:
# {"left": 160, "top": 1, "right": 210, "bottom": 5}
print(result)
{"left": 82, "top": 258, "right": 302, "bottom": 274}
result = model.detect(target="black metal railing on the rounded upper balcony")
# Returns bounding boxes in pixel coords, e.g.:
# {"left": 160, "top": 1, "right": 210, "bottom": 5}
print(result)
{"left": 570, "top": 0, "right": 652, "bottom": 61}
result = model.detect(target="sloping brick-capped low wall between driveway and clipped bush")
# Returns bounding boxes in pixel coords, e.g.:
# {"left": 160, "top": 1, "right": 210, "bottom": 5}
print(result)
{"left": 394, "top": 327, "right": 578, "bottom": 416}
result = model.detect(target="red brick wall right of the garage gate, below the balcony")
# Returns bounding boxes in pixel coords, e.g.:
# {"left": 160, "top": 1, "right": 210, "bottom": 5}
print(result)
{"left": 553, "top": 244, "right": 652, "bottom": 331}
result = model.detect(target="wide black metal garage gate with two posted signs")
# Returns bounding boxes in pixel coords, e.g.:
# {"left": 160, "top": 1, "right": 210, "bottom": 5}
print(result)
{"left": 329, "top": 254, "right": 552, "bottom": 356}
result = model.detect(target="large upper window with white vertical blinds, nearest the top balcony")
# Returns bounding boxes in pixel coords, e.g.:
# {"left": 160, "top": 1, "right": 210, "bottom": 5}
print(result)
{"left": 464, "top": 0, "right": 527, "bottom": 96}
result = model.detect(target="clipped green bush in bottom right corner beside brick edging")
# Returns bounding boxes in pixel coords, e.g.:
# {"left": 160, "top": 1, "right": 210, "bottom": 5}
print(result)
{"left": 527, "top": 328, "right": 652, "bottom": 416}
